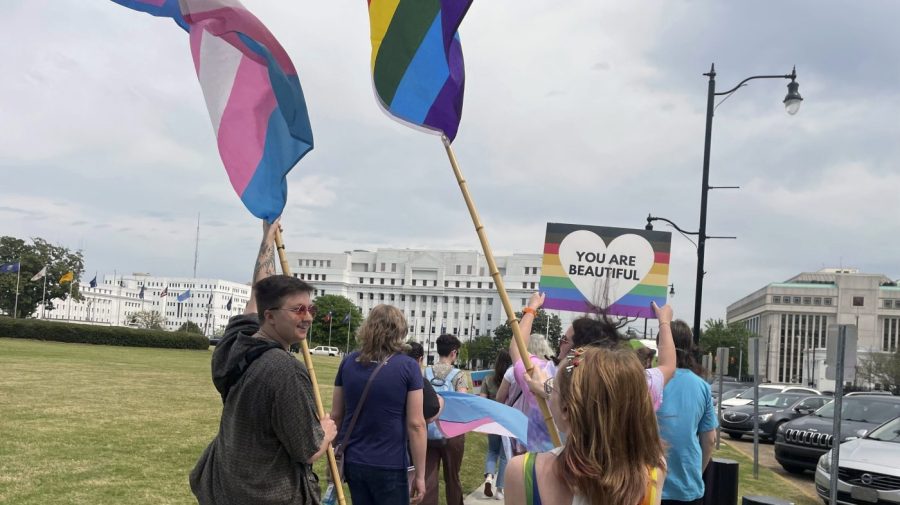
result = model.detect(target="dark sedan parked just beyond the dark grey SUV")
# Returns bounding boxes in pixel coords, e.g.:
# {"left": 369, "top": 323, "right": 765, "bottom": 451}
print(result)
{"left": 719, "top": 393, "right": 831, "bottom": 441}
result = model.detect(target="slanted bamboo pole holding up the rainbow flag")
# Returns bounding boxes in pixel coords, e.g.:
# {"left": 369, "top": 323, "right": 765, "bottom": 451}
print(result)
{"left": 441, "top": 135, "right": 562, "bottom": 447}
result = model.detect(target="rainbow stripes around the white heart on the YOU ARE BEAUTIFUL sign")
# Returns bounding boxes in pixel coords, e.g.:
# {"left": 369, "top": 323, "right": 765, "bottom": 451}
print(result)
{"left": 540, "top": 223, "right": 672, "bottom": 319}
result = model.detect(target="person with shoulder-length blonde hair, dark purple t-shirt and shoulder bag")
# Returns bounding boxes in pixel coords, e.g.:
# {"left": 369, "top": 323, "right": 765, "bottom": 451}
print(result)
{"left": 331, "top": 305, "right": 427, "bottom": 505}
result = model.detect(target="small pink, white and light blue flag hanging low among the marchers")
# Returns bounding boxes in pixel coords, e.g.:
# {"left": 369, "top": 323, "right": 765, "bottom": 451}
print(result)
{"left": 436, "top": 391, "right": 528, "bottom": 444}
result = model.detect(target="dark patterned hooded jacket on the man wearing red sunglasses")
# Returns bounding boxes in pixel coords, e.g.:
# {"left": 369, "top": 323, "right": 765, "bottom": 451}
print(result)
{"left": 190, "top": 314, "right": 324, "bottom": 505}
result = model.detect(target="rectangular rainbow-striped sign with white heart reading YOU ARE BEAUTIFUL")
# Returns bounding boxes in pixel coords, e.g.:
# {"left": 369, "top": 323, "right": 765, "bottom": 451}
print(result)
{"left": 540, "top": 223, "right": 672, "bottom": 318}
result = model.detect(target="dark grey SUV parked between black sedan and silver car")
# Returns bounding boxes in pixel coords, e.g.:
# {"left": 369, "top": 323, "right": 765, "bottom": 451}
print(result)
{"left": 775, "top": 395, "right": 900, "bottom": 473}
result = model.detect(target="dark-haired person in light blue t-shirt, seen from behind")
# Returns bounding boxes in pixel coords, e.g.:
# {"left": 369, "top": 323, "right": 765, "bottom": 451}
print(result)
{"left": 656, "top": 320, "right": 718, "bottom": 505}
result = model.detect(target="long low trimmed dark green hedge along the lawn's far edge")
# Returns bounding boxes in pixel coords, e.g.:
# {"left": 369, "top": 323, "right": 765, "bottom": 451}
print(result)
{"left": 0, "top": 317, "right": 209, "bottom": 350}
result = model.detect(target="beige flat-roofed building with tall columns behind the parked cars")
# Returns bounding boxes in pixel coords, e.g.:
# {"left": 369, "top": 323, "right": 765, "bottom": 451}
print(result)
{"left": 726, "top": 268, "right": 900, "bottom": 390}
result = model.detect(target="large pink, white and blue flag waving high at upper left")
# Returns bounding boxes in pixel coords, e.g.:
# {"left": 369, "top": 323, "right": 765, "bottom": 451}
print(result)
{"left": 113, "top": 0, "right": 313, "bottom": 222}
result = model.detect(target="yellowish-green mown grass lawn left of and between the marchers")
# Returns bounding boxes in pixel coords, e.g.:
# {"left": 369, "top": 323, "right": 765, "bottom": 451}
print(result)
{"left": 0, "top": 338, "right": 487, "bottom": 505}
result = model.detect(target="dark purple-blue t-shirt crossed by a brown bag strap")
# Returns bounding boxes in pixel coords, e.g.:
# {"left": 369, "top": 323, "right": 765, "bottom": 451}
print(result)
{"left": 334, "top": 352, "right": 422, "bottom": 470}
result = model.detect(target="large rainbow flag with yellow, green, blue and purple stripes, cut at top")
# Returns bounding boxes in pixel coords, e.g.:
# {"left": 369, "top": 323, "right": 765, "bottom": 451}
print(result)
{"left": 369, "top": 0, "right": 472, "bottom": 142}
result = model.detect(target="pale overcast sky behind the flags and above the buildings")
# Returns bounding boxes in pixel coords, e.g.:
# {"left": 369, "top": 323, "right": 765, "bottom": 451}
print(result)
{"left": 0, "top": 0, "right": 900, "bottom": 321}
